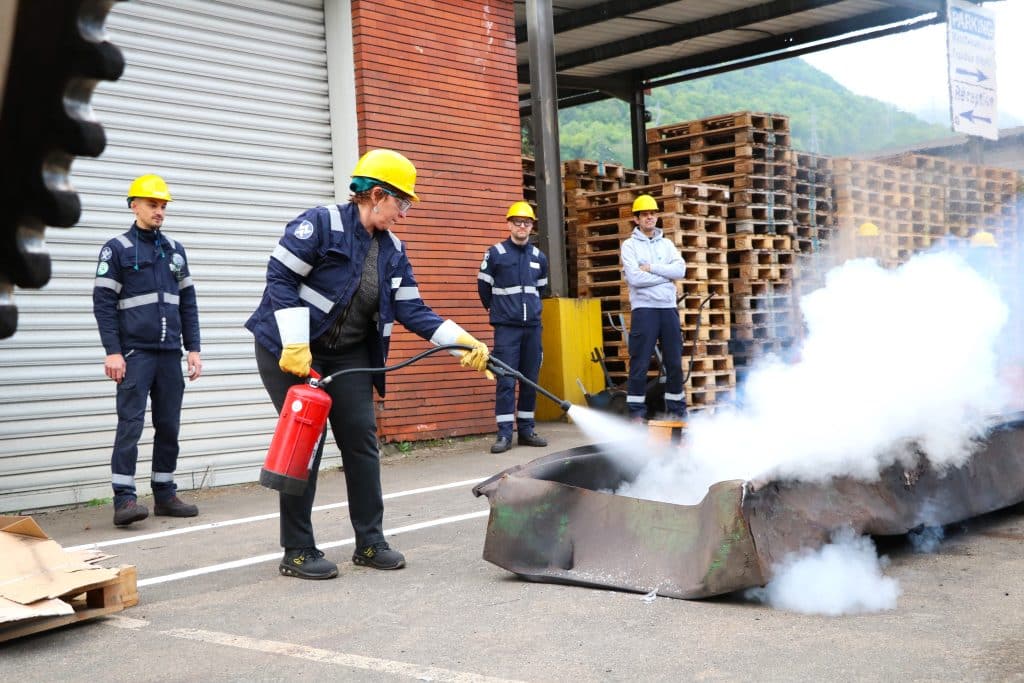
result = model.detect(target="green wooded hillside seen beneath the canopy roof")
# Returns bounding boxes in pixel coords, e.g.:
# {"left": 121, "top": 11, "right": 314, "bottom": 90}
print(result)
{"left": 544, "top": 59, "right": 950, "bottom": 165}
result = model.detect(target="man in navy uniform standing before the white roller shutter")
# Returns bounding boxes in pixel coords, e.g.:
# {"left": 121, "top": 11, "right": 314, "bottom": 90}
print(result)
{"left": 92, "top": 174, "right": 203, "bottom": 526}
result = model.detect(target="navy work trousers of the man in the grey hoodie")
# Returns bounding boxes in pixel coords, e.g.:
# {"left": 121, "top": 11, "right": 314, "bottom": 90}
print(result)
{"left": 626, "top": 308, "right": 686, "bottom": 418}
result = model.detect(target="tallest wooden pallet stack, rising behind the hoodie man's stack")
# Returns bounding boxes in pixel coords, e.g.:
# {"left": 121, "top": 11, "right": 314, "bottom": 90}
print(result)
{"left": 647, "top": 112, "right": 798, "bottom": 376}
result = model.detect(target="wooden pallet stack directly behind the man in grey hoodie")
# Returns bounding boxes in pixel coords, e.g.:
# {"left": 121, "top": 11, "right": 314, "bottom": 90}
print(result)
{"left": 577, "top": 182, "right": 735, "bottom": 410}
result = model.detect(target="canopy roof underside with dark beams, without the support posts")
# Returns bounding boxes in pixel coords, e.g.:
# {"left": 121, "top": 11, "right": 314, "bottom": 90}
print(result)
{"left": 515, "top": 0, "right": 954, "bottom": 108}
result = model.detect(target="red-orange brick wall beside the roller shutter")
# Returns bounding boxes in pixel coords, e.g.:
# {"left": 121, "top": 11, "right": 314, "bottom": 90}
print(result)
{"left": 352, "top": 0, "right": 522, "bottom": 441}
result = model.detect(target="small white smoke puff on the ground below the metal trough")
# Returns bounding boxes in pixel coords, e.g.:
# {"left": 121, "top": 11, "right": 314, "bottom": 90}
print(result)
{"left": 744, "top": 528, "right": 901, "bottom": 616}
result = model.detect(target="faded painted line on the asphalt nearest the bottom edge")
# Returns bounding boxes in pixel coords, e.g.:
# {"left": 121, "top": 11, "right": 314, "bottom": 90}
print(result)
{"left": 161, "top": 629, "right": 528, "bottom": 683}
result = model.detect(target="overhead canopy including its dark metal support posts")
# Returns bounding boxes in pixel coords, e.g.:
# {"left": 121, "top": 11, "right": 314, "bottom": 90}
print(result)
{"left": 514, "top": 0, "right": 970, "bottom": 296}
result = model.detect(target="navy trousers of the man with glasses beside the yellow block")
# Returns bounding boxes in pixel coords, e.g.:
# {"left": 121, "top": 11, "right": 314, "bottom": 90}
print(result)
{"left": 494, "top": 325, "right": 543, "bottom": 439}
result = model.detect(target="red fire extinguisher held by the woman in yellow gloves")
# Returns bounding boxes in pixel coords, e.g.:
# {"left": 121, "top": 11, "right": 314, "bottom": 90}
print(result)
{"left": 259, "top": 370, "right": 331, "bottom": 496}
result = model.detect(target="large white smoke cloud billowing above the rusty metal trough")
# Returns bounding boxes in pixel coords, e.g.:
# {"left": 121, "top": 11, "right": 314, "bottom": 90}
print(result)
{"left": 616, "top": 252, "right": 1009, "bottom": 505}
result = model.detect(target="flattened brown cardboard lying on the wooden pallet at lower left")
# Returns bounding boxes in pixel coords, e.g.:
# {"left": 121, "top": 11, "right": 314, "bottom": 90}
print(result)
{"left": 0, "top": 515, "right": 118, "bottom": 624}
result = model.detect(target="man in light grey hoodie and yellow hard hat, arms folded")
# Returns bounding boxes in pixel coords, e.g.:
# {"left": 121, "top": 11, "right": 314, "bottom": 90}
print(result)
{"left": 622, "top": 195, "right": 686, "bottom": 421}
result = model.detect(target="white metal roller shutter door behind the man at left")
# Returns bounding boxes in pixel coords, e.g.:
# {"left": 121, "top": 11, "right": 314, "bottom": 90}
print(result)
{"left": 0, "top": 0, "right": 338, "bottom": 511}
